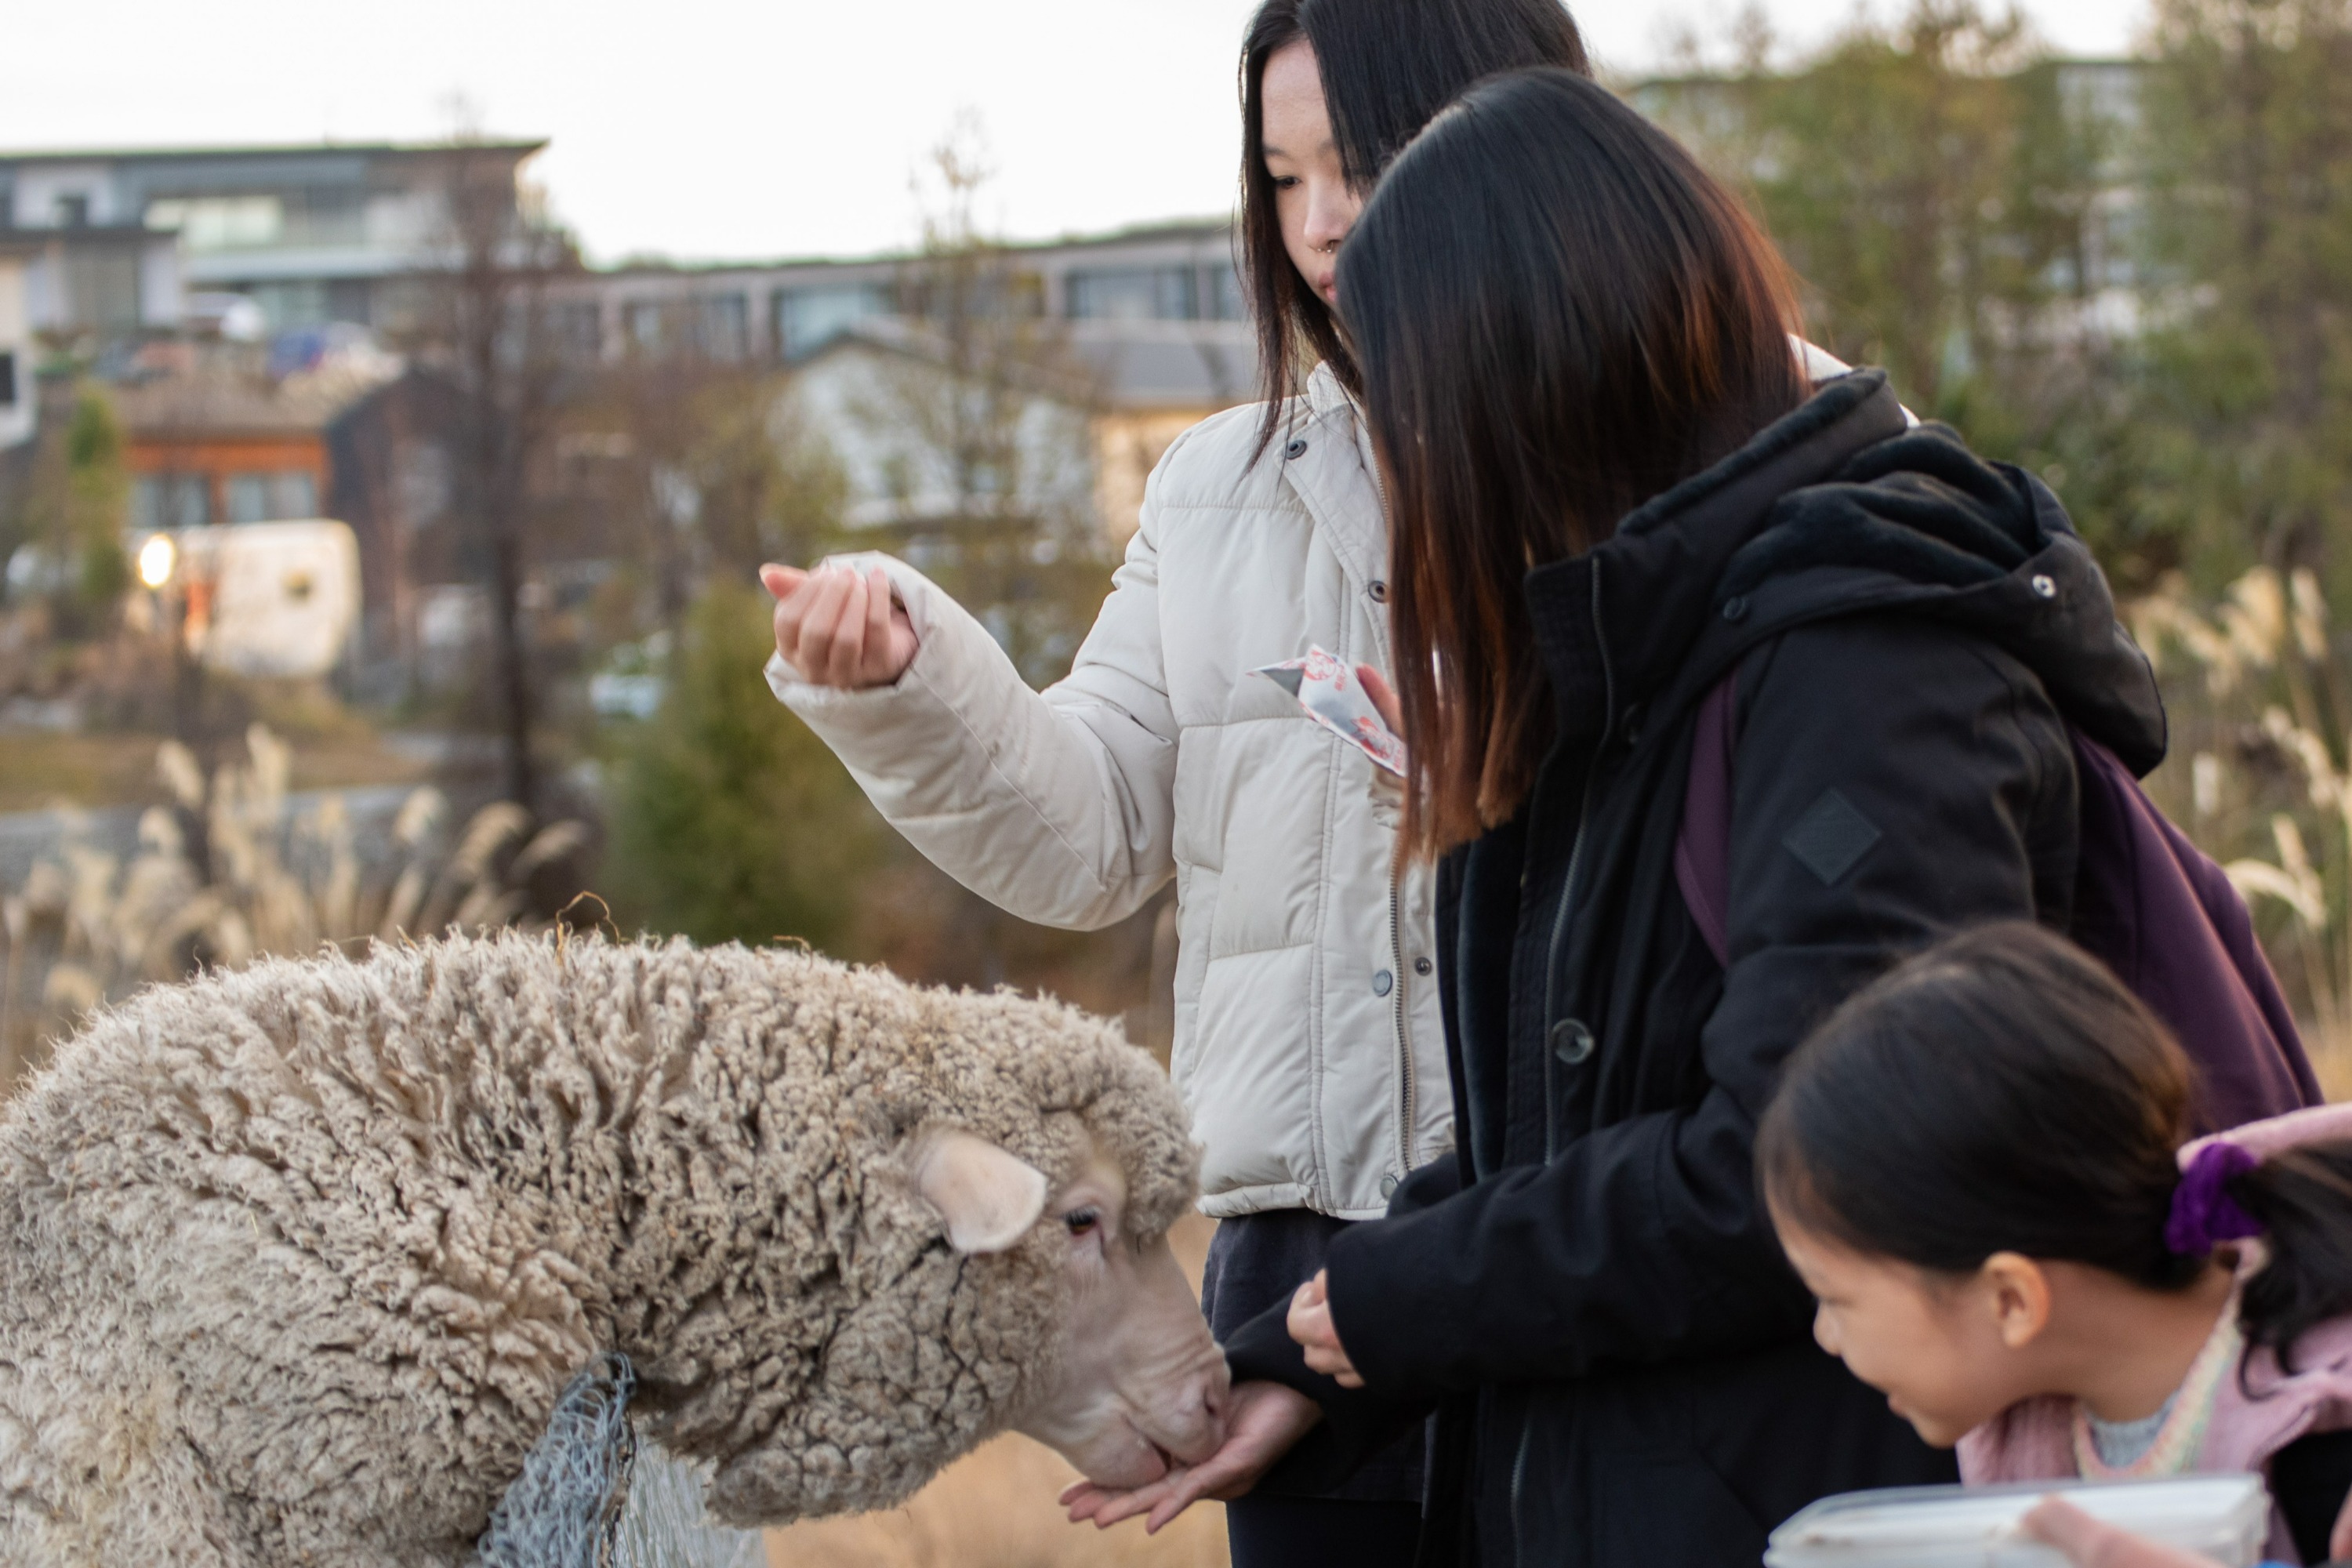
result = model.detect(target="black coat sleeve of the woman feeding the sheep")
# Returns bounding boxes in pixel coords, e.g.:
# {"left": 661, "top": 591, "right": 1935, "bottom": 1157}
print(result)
{"left": 1329, "top": 621, "right": 2074, "bottom": 1399}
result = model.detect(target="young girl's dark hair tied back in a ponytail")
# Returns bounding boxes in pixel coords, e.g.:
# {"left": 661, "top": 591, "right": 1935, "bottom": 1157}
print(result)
{"left": 1757, "top": 921, "right": 2352, "bottom": 1368}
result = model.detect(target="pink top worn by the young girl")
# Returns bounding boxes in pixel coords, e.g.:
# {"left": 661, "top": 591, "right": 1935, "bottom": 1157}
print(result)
{"left": 1959, "top": 1105, "right": 2352, "bottom": 1563}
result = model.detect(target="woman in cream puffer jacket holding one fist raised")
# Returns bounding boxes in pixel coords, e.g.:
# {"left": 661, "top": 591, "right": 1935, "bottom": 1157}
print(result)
{"left": 764, "top": 12, "right": 1585, "bottom": 1568}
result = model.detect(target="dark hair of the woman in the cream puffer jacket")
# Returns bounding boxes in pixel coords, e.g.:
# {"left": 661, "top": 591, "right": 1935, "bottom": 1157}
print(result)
{"left": 1242, "top": 0, "right": 1590, "bottom": 452}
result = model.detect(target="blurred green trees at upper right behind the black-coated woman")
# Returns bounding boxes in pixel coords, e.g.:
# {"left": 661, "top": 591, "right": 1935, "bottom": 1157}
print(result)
{"left": 1637, "top": 0, "right": 2352, "bottom": 604}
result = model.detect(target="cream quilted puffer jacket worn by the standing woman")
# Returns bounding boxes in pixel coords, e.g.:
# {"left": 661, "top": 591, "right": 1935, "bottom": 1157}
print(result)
{"left": 769, "top": 369, "right": 1454, "bottom": 1220}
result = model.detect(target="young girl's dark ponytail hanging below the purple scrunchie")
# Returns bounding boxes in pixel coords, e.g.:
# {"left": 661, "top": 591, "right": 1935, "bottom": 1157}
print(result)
{"left": 2227, "top": 1140, "right": 2352, "bottom": 1375}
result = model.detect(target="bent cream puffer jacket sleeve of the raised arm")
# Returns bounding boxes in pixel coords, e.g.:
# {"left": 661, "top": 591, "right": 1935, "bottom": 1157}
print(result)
{"left": 767, "top": 440, "right": 1183, "bottom": 931}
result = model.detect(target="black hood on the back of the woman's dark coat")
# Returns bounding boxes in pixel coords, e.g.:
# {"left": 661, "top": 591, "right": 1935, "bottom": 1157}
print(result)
{"left": 1526, "top": 369, "right": 2166, "bottom": 774}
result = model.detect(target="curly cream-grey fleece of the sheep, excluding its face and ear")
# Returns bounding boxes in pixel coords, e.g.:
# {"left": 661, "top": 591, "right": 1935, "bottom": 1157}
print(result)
{"left": 0, "top": 933, "right": 1195, "bottom": 1568}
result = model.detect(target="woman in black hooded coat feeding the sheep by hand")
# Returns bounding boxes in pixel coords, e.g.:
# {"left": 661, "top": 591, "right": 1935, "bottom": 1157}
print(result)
{"left": 1101, "top": 71, "right": 2164, "bottom": 1568}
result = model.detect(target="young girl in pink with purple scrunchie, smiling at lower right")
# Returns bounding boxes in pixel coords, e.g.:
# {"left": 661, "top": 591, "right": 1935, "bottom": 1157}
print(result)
{"left": 1757, "top": 924, "right": 2352, "bottom": 1563}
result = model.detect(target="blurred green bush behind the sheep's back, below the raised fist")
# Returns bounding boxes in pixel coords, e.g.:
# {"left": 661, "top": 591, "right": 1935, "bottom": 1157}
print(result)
{"left": 607, "top": 581, "right": 887, "bottom": 947}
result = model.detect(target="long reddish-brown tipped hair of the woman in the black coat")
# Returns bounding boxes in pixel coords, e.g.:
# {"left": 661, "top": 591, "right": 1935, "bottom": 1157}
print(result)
{"left": 1338, "top": 71, "right": 1806, "bottom": 855}
